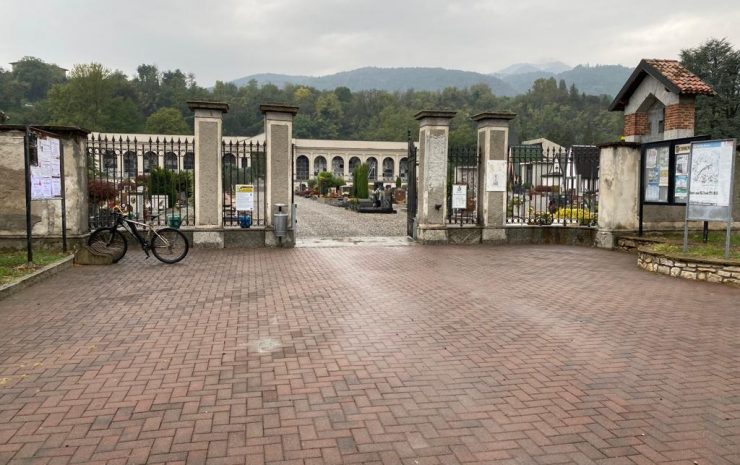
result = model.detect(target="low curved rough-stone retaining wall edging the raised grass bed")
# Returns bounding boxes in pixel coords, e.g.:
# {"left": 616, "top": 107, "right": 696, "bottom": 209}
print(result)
{"left": 637, "top": 249, "right": 740, "bottom": 286}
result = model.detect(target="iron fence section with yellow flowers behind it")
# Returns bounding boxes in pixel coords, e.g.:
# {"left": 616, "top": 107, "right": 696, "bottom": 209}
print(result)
{"left": 506, "top": 145, "right": 599, "bottom": 226}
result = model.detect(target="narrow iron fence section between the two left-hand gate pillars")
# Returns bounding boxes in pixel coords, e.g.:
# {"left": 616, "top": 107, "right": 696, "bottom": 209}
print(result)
{"left": 222, "top": 141, "right": 267, "bottom": 227}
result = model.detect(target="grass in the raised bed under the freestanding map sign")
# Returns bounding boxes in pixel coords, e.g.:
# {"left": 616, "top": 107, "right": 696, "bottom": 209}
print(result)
{"left": 651, "top": 231, "right": 740, "bottom": 260}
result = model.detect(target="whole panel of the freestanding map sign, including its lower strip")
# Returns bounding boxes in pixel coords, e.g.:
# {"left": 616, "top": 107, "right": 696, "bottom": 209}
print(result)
{"left": 686, "top": 139, "right": 736, "bottom": 221}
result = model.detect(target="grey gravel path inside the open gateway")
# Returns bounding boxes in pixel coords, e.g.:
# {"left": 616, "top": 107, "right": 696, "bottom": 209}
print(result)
{"left": 295, "top": 196, "right": 406, "bottom": 239}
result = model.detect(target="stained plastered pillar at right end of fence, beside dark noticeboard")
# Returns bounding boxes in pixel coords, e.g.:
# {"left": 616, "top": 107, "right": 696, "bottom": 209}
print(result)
{"left": 596, "top": 142, "right": 640, "bottom": 249}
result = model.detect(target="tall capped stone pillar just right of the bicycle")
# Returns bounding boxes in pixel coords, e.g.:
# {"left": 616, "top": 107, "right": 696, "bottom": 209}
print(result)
{"left": 188, "top": 101, "right": 229, "bottom": 248}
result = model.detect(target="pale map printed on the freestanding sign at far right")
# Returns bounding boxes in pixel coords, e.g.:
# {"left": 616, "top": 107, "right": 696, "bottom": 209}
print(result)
{"left": 689, "top": 140, "right": 735, "bottom": 207}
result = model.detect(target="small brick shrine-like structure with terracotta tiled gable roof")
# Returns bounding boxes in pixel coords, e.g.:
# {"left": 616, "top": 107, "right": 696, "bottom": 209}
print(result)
{"left": 609, "top": 59, "right": 714, "bottom": 143}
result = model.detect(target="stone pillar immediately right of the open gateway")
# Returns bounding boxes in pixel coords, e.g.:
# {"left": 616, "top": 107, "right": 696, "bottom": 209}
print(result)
{"left": 415, "top": 111, "right": 456, "bottom": 244}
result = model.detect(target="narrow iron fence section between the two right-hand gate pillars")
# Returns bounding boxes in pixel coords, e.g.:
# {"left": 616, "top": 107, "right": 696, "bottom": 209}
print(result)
{"left": 447, "top": 147, "right": 480, "bottom": 226}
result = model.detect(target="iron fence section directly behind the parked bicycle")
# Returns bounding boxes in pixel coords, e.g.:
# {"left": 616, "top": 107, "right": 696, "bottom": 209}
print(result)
{"left": 87, "top": 135, "right": 195, "bottom": 229}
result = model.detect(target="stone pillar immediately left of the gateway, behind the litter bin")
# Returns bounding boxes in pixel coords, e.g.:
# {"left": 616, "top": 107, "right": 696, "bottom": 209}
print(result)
{"left": 260, "top": 105, "right": 296, "bottom": 247}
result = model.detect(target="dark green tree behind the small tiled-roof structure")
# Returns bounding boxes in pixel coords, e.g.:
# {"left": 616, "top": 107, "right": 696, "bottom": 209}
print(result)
{"left": 681, "top": 39, "right": 740, "bottom": 138}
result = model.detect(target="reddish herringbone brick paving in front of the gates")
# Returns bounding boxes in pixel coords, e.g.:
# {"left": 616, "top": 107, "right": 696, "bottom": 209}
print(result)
{"left": 0, "top": 246, "right": 740, "bottom": 465}
